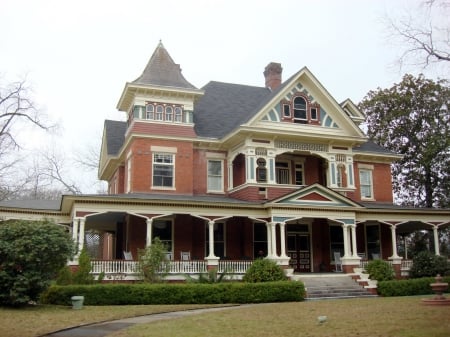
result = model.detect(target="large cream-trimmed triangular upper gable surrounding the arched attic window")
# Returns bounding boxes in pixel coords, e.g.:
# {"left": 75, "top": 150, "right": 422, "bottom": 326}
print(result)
{"left": 246, "top": 68, "right": 366, "bottom": 139}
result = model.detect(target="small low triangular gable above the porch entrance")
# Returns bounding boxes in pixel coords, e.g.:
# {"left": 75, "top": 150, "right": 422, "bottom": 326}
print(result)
{"left": 271, "top": 184, "right": 361, "bottom": 207}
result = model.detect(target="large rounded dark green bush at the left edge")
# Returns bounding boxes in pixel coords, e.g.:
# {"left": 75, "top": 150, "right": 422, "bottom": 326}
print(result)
{"left": 0, "top": 221, "right": 74, "bottom": 306}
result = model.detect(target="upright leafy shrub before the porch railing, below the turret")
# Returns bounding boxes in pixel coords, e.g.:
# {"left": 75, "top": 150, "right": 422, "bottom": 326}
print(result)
{"left": 138, "top": 237, "right": 169, "bottom": 282}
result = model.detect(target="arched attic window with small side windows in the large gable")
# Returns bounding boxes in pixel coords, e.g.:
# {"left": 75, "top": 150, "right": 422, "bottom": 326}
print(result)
{"left": 281, "top": 94, "right": 320, "bottom": 124}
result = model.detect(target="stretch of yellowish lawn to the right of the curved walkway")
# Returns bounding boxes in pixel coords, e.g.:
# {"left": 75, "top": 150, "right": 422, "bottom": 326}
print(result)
{"left": 111, "top": 296, "right": 450, "bottom": 337}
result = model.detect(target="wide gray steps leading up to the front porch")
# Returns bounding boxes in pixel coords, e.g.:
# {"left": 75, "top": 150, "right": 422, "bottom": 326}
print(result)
{"left": 292, "top": 273, "right": 376, "bottom": 300}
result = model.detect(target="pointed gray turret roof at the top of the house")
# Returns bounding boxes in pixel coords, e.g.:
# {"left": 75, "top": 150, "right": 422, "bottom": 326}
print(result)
{"left": 132, "top": 41, "right": 197, "bottom": 89}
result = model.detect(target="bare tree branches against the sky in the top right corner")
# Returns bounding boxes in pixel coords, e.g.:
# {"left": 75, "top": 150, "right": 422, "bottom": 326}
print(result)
{"left": 386, "top": 0, "right": 450, "bottom": 70}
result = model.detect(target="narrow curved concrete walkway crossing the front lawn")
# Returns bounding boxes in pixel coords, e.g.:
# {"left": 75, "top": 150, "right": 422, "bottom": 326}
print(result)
{"left": 42, "top": 304, "right": 255, "bottom": 337}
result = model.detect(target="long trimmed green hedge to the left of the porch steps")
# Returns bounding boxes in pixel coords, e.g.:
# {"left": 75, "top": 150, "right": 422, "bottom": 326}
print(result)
{"left": 41, "top": 281, "right": 305, "bottom": 305}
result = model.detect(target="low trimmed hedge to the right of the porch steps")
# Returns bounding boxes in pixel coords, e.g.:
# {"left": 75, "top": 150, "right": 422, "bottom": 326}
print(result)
{"left": 377, "top": 276, "right": 450, "bottom": 297}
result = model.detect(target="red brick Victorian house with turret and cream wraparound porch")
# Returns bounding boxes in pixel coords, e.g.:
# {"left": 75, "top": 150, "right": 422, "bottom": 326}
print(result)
{"left": 0, "top": 43, "right": 450, "bottom": 277}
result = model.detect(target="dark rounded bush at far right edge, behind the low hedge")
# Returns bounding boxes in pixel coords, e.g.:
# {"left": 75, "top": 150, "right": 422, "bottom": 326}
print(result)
{"left": 410, "top": 251, "right": 450, "bottom": 278}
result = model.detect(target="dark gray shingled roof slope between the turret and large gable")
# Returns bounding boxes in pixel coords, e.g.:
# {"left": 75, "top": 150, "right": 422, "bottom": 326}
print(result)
{"left": 194, "top": 82, "right": 272, "bottom": 138}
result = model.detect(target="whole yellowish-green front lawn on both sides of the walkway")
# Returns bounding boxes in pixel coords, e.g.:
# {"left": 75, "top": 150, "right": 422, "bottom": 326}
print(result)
{"left": 0, "top": 296, "right": 450, "bottom": 337}
